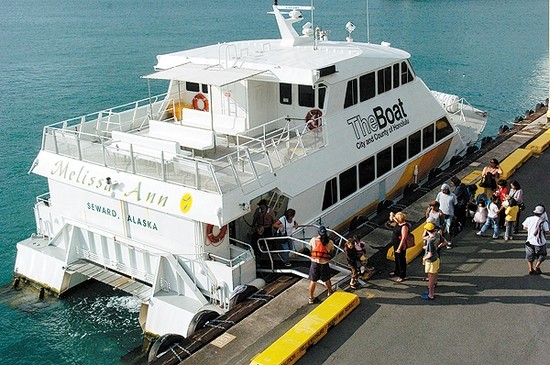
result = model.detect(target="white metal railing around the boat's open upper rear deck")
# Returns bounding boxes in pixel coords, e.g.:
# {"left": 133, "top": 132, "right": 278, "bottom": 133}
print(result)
{"left": 42, "top": 95, "right": 326, "bottom": 194}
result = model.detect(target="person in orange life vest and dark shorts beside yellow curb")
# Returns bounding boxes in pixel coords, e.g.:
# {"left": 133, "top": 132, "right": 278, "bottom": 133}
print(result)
{"left": 309, "top": 226, "right": 335, "bottom": 304}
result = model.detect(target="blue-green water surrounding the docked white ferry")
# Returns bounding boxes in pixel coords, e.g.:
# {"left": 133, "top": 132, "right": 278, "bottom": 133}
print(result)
{"left": 0, "top": 0, "right": 549, "bottom": 364}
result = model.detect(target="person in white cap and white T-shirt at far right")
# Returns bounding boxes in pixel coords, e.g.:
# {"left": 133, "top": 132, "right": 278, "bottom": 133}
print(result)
{"left": 522, "top": 205, "right": 550, "bottom": 275}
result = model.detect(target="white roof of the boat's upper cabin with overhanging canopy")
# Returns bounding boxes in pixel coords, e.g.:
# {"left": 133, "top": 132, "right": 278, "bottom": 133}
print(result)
{"left": 144, "top": 38, "right": 410, "bottom": 86}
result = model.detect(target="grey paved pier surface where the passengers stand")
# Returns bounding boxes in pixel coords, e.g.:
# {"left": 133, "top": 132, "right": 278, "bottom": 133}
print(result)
{"left": 182, "top": 114, "right": 550, "bottom": 365}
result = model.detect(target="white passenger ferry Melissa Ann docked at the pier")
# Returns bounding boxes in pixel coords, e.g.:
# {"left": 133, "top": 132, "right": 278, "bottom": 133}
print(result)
{"left": 15, "top": 4, "right": 486, "bottom": 336}
